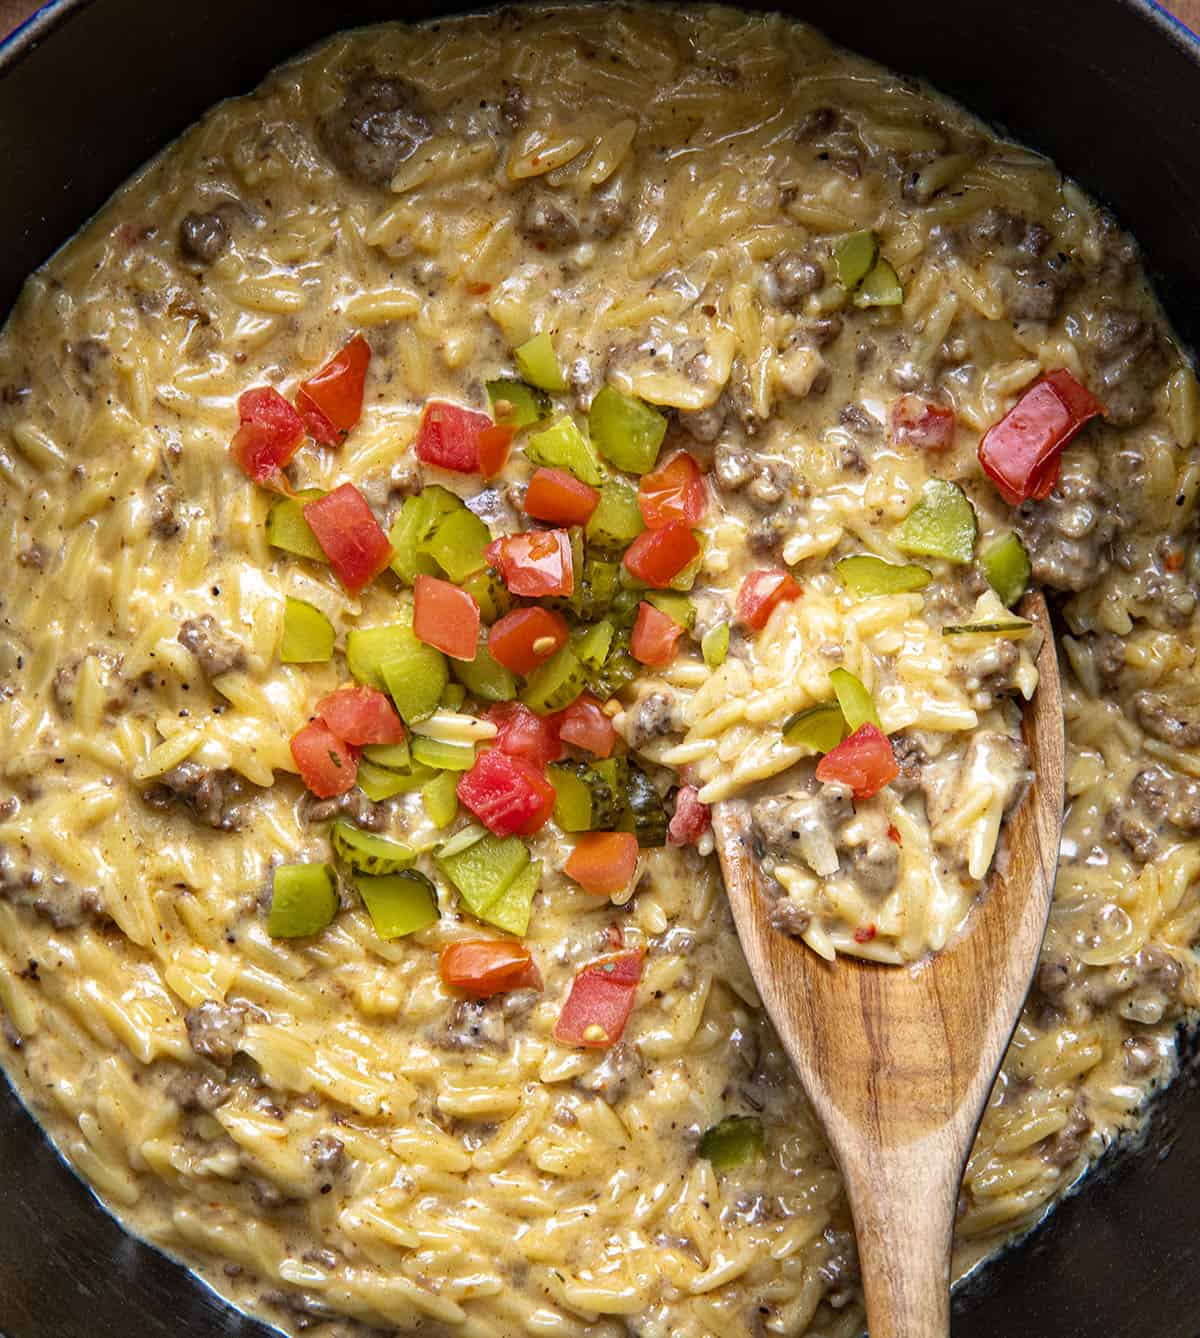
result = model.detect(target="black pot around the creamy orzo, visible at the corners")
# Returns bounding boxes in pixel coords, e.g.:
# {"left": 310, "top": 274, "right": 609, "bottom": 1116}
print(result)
{"left": 0, "top": 0, "right": 1200, "bottom": 1338}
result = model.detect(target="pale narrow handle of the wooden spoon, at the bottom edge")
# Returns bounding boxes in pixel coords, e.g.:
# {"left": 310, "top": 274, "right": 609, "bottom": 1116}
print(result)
{"left": 843, "top": 1135, "right": 962, "bottom": 1338}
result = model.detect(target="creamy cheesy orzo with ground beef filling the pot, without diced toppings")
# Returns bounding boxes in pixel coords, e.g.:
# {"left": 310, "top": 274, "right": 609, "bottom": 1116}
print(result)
{"left": 0, "top": 7, "right": 1200, "bottom": 1338}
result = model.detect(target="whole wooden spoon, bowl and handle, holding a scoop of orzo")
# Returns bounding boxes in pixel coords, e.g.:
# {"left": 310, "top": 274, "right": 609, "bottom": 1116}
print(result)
{"left": 714, "top": 595, "right": 1064, "bottom": 1338}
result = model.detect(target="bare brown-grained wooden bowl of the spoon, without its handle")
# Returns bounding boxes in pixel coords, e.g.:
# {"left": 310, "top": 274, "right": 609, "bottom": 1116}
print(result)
{"left": 714, "top": 595, "right": 1064, "bottom": 1166}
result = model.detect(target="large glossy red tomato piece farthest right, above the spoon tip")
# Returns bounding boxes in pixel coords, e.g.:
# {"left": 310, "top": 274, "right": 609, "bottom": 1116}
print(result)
{"left": 979, "top": 368, "right": 1108, "bottom": 506}
